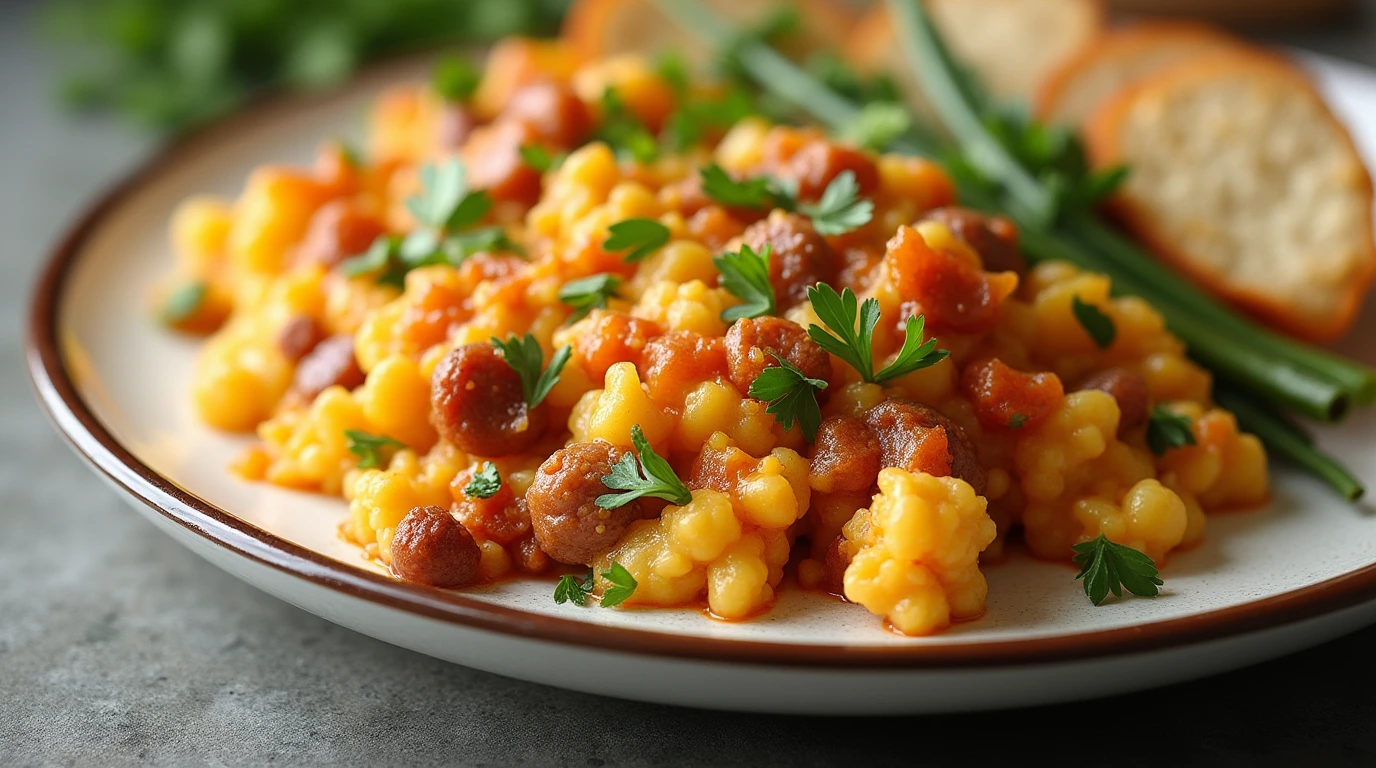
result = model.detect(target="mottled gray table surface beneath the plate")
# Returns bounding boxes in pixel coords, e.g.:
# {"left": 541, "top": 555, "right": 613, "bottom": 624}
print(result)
{"left": 8, "top": 0, "right": 1376, "bottom": 767}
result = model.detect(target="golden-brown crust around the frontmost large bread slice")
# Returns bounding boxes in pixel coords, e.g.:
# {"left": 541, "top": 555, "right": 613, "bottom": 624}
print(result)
{"left": 1084, "top": 51, "right": 1376, "bottom": 341}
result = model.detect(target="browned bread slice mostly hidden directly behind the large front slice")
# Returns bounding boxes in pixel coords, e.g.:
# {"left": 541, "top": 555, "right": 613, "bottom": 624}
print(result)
{"left": 1033, "top": 21, "right": 1245, "bottom": 125}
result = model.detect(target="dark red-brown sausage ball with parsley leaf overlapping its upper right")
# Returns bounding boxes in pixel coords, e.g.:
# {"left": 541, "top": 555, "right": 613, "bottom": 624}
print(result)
{"left": 431, "top": 344, "right": 549, "bottom": 458}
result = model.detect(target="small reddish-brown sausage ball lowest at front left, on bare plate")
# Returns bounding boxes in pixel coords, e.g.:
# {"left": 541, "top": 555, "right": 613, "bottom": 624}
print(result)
{"left": 392, "top": 506, "right": 482, "bottom": 588}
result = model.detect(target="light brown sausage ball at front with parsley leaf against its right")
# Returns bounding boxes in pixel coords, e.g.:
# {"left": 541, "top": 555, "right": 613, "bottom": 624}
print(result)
{"left": 526, "top": 440, "right": 641, "bottom": 566}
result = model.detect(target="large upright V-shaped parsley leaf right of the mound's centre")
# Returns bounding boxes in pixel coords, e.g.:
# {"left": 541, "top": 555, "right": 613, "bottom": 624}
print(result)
{"left": 808, "top": 282, "right": 949, "bottom": 384}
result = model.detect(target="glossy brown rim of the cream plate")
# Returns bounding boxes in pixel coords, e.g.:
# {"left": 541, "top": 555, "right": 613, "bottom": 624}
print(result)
{"left": 25, "top": 67, "right": 1376, "bottom": 669}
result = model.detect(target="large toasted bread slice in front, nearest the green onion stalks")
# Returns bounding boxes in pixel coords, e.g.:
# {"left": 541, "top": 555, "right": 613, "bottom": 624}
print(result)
{"left": 1086, "top": 51, "right": 1376, "bottom": 341}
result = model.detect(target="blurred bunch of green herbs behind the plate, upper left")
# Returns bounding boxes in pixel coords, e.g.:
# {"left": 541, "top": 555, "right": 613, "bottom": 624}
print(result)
{"left": 44, "top": 0, "right": 570, "bottom": 129}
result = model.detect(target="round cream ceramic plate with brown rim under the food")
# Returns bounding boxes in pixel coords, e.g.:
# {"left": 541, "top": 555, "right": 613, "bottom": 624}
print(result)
{"left": 18, "top": 52, "right": 1376, "bottom": 714}
